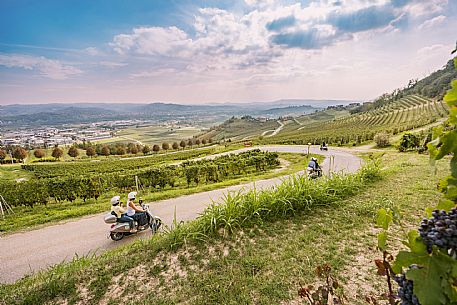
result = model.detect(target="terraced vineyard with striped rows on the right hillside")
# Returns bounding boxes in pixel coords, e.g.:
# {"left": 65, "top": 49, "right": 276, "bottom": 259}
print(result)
{"left": 264, "top": 95, "right": 448, "bottom": 144}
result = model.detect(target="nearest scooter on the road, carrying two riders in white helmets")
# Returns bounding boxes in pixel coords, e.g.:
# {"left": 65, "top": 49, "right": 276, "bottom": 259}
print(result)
{"left": 105, "top": 202, "right": 162, "bottom": 241}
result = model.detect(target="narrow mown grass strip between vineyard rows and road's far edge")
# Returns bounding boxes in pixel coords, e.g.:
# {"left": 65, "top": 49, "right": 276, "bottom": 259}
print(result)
{"left": 0, "top": 153, "right": 312, "bottom": 233}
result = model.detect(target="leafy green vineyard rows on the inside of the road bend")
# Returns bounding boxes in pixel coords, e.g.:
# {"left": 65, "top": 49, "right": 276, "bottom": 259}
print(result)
{"left": 0, "top": 150, "right": 279, "bottom": 207}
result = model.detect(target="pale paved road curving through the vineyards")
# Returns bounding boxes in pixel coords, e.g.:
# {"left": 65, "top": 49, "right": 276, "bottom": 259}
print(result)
{"left": 0, "top": 146, "right": 362, "bottom": 283}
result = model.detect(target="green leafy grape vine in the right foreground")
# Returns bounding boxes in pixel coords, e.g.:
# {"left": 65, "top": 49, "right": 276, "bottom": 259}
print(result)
{"left": 376, "top": 58, "right": 457, "bottom": 305}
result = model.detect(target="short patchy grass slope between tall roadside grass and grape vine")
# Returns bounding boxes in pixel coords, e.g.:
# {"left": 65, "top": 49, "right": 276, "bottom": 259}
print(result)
{"left": 138, "top": 153, "right": 449, "bottom": 304}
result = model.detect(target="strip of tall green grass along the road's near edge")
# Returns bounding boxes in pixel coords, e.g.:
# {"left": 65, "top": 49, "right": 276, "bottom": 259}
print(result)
{"left": 0, "top": 162, "right": 381, "bottom": 304}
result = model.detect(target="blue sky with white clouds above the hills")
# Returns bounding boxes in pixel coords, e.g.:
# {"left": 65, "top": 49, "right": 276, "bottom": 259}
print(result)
{"left": 0, "top": 0, "right": 457, "bottom": 104}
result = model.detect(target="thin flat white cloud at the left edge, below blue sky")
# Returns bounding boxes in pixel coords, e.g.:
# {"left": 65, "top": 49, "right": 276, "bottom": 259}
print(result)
{"left": 0, "top": 54, "right": 82, "bottom": 80}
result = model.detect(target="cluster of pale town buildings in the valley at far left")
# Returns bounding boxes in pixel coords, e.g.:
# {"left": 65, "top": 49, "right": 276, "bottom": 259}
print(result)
{"left": 0, "top": 128, "right": 113, "bottom": 147}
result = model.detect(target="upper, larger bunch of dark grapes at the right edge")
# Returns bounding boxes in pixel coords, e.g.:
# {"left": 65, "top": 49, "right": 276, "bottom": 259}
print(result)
{"left": 419, "top": 208, "right": 457, "bottom": 256}
